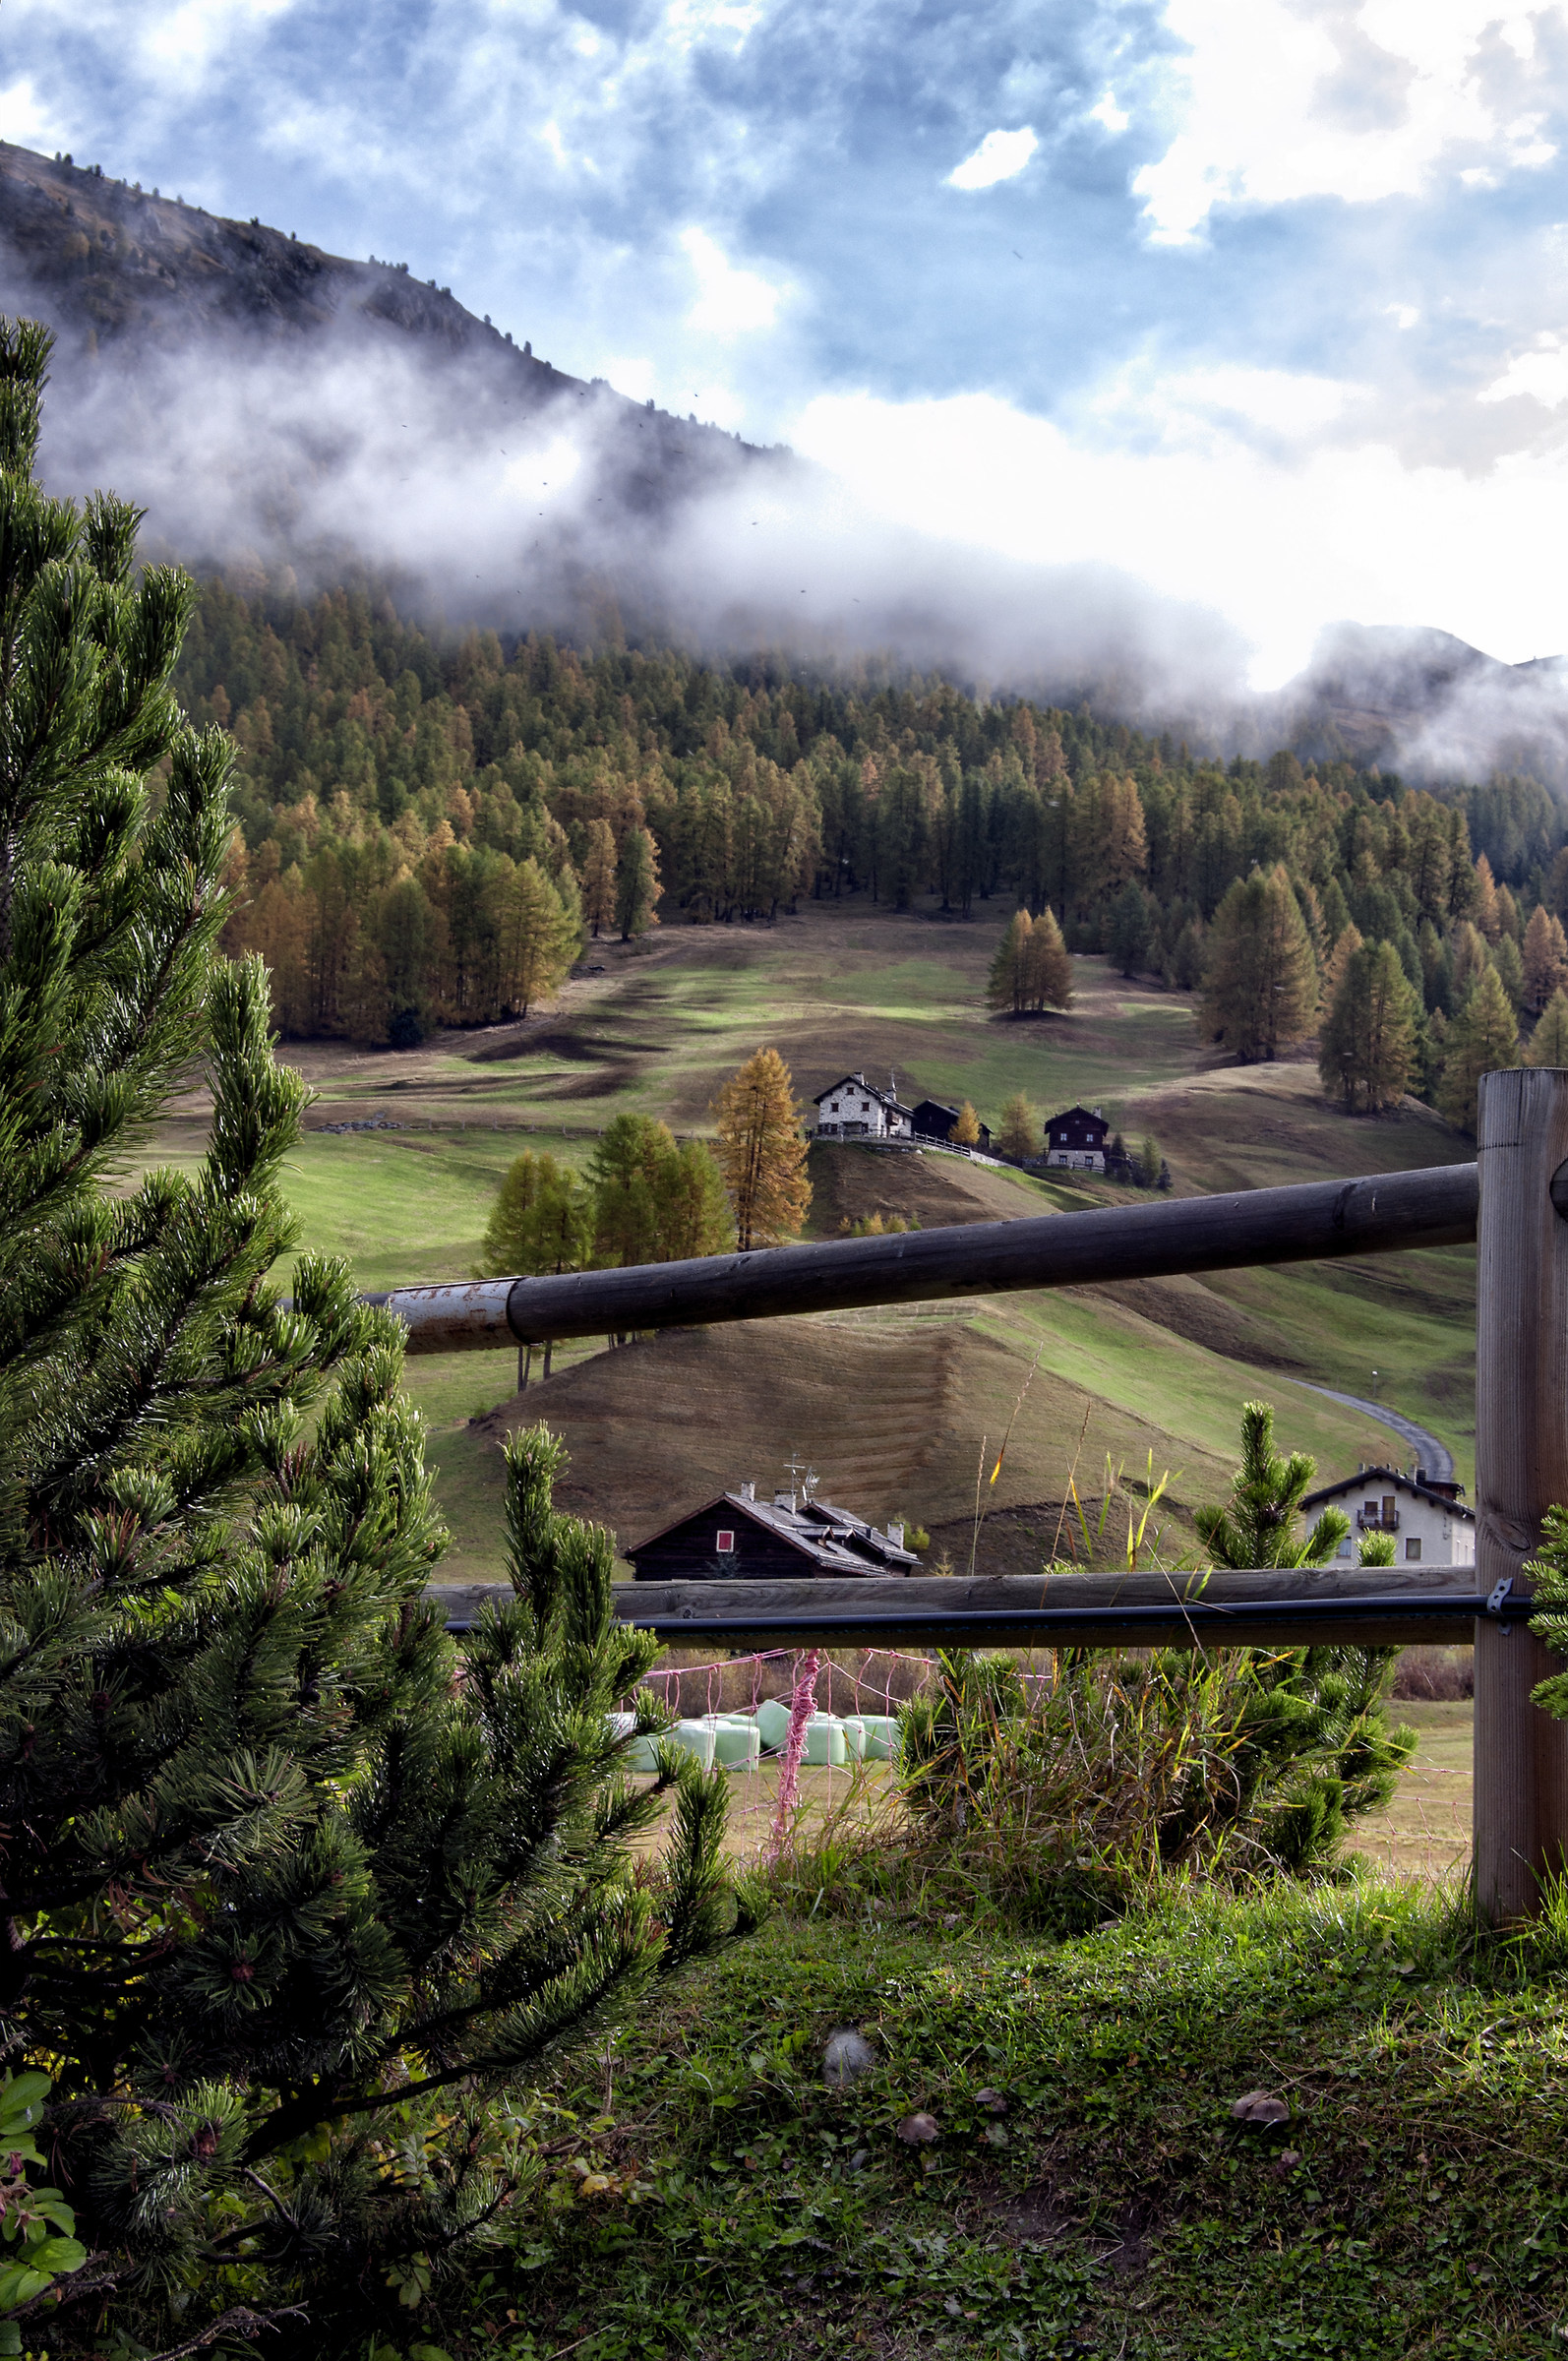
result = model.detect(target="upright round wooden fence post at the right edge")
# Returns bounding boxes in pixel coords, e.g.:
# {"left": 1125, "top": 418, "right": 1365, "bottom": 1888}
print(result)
{"left": 1474, "top": 1067, "right": 1568, "bottom": 1922}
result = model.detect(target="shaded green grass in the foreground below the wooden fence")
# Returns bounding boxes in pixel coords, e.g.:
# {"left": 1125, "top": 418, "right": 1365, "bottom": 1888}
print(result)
{"left": 416, "top": 1882, "right": 1568, "bottom": 2361}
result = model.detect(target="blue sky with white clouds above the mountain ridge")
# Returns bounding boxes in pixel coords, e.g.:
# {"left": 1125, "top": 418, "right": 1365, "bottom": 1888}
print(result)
{"left": 0, "top": 0, "right": 1568, "bottom": 690}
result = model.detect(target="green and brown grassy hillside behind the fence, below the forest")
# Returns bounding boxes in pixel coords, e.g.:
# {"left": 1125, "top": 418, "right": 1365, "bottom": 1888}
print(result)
{"left": 137, "top": 904, "right": 1474, "bottom": 1580}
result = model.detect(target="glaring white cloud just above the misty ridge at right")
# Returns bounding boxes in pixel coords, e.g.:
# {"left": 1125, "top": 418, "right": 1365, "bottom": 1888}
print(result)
{"left": 791, "top": 383, "right": 1568, "bottom": 690}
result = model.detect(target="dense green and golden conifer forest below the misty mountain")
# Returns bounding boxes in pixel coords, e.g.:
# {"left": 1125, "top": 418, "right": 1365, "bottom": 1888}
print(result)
{"left": 179, "top": 583, "right": 1568, "bottom": 1120}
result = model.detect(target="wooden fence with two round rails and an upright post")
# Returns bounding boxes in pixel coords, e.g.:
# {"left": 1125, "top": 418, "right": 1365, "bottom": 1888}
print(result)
{"left": 376, "top": 1067, "right": 1568, "bottom": 1922}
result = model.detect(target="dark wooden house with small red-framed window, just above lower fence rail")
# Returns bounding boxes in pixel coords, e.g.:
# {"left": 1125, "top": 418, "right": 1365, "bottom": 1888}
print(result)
{"left": 626, "top": 1483, "right": 919, "bottom": 1582}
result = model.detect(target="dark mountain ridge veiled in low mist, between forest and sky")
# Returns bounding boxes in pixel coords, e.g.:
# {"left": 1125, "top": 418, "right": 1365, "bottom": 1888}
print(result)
{"left": 0, "top": 144, "right": 1568, "bottom": 786}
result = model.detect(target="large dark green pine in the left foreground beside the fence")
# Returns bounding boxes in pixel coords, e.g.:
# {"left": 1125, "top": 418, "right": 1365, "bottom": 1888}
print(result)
{"left": 0, "top": 324, "right": 725, "bottom": 2351}
